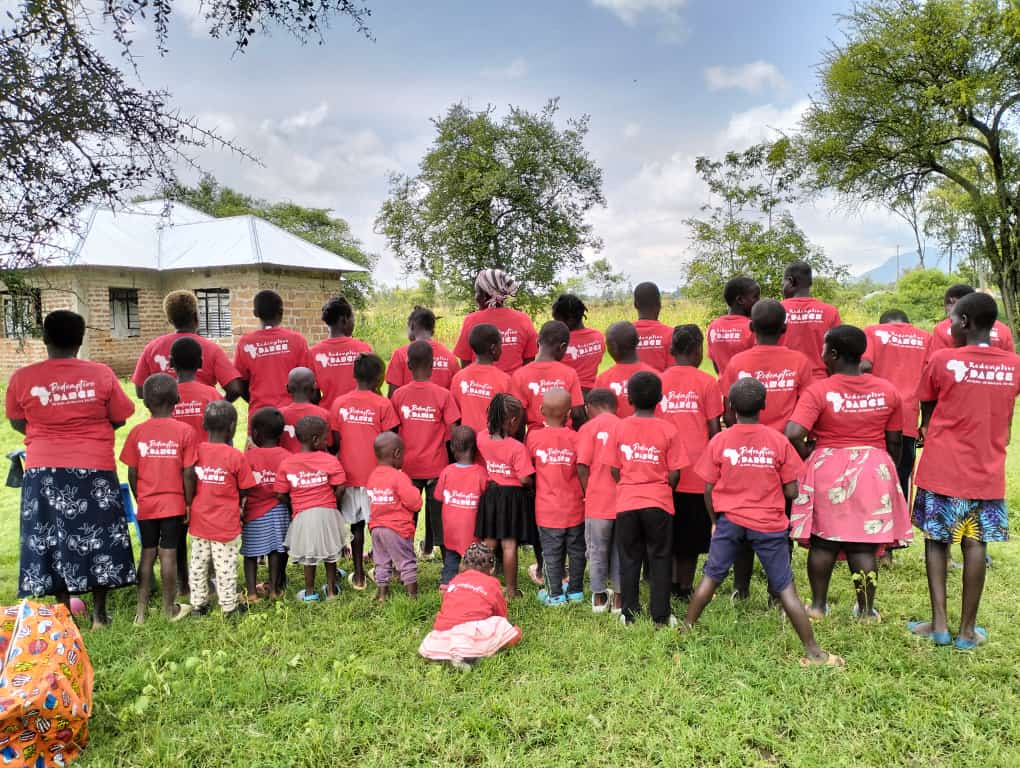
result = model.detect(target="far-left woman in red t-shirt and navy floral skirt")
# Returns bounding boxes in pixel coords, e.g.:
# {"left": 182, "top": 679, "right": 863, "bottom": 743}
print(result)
{"left": 6, "top": 310, "right": 136, "bottom": 628}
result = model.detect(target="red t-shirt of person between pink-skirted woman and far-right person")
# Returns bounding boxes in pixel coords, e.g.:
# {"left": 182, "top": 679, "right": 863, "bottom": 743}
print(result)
{"left": 864, "top": 322, "right": 931, "bottom": 438}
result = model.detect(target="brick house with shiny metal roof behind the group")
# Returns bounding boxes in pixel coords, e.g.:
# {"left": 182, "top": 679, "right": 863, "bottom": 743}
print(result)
{"left": 0, "top": 200, "right": 367, "bottom": 379}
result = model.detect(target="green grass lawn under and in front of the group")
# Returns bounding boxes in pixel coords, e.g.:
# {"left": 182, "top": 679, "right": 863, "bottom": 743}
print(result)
{"left": 0, "top": 299, "right": 1020, "bottom": 768}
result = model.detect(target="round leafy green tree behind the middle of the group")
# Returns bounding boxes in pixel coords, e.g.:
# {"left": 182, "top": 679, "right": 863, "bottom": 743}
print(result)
{"left": 375, "top": 100, "right": 605, "bottom": 308}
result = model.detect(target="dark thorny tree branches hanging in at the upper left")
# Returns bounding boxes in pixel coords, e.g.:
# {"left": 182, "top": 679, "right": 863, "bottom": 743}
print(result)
{"left": 0, "top": 0, "right": 369, "bottom": 269}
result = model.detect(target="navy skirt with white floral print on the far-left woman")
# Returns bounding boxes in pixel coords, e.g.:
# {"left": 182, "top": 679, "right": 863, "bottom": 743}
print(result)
{"left": 17, "top": 467, "right": 136, "bottom": 598}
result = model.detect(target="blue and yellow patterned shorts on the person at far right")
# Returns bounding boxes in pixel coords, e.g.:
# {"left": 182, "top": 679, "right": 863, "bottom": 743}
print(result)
{"left": 913, "top": 488, "right": 1010, "bottom": 544}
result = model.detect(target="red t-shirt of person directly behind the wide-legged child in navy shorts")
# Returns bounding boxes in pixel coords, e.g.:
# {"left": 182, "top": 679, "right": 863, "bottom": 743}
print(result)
{"left": 719, "top": 347, "right": 815, "bottom": 432}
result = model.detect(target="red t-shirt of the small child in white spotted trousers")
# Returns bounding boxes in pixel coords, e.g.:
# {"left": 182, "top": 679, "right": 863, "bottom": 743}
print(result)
{"left": 188, "top": 443, "right": 257, "bottom": 542}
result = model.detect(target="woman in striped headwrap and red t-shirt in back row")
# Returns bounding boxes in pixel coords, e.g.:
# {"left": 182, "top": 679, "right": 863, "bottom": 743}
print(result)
{"left": 453, "top": 269, "right": 539, "bottom": 373}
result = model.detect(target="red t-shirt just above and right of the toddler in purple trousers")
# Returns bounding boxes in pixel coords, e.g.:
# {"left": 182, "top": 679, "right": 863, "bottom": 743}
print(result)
{"left": 393, "top": 381, "right": 460, "bottom": 480}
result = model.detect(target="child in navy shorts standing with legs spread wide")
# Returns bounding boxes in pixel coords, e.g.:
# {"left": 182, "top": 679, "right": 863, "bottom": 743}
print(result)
{"left": 683, "top": 378, "right": 844, "bottom": 666}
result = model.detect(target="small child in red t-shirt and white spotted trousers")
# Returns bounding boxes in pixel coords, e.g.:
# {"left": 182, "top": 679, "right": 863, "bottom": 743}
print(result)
{"left": 189, "top": 400, "right": 256, "bottom": 616}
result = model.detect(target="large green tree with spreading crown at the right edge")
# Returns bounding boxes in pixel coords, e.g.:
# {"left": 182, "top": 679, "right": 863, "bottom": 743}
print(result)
{"left": 802, "top": 0, "right": 1020, "bottom": 329}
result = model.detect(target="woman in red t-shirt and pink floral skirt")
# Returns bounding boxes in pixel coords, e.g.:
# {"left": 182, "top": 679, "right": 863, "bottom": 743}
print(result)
{"left": 785, "top": 325, "right": 913, "bottom": 621}
